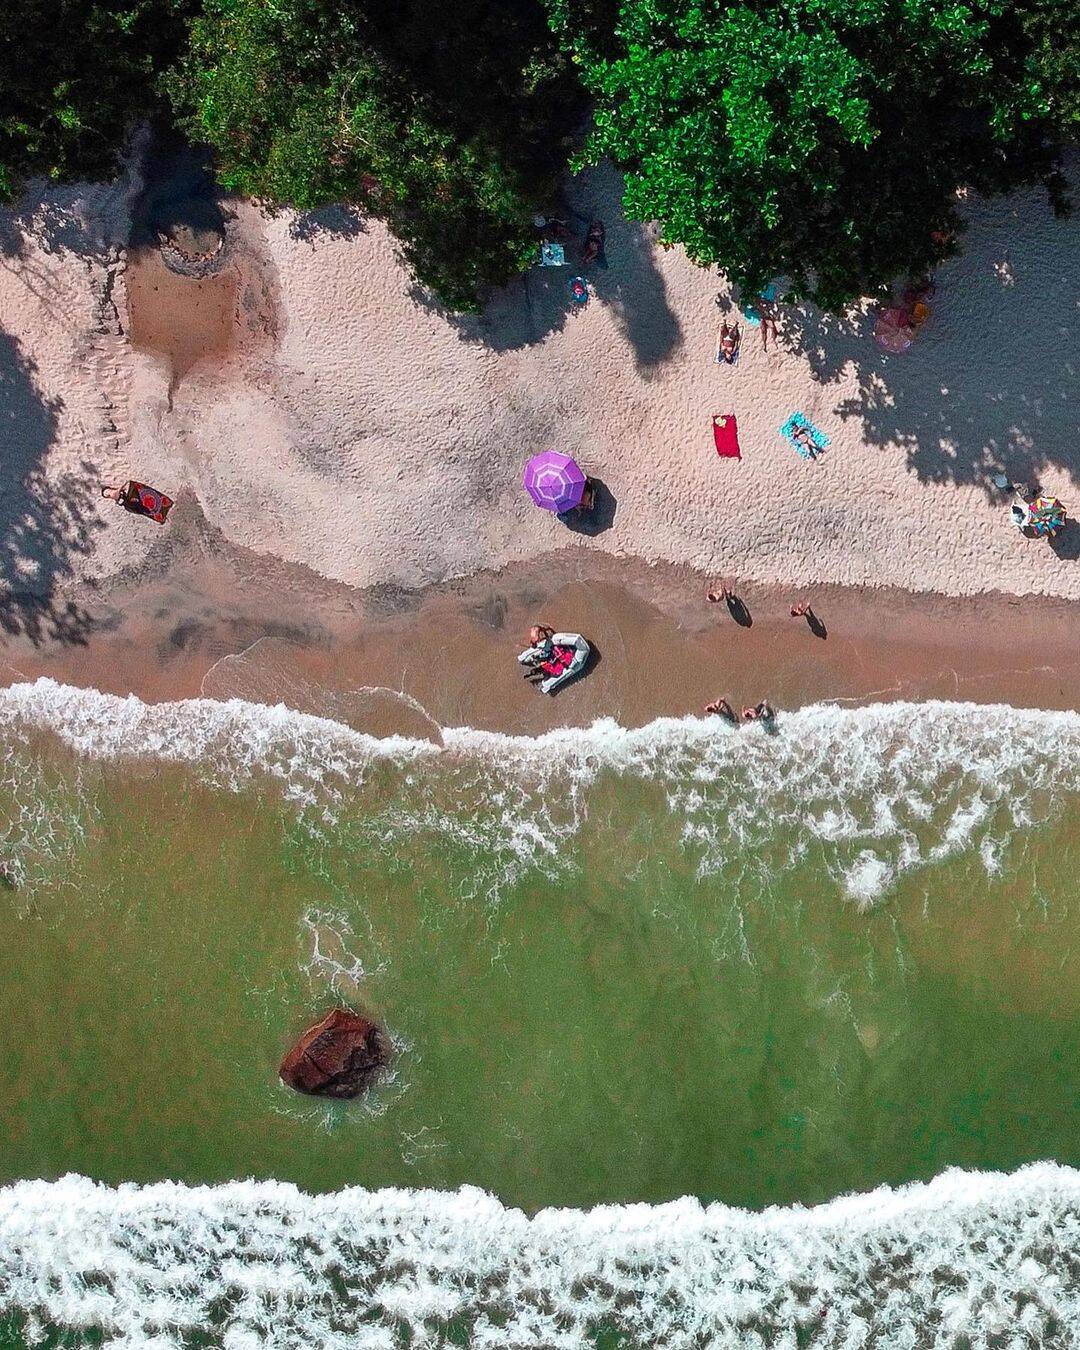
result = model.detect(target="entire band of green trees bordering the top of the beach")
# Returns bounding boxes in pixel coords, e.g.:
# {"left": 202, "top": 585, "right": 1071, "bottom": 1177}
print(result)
{"left": 0, "top": 0, "right": 1080, "bottom": 309}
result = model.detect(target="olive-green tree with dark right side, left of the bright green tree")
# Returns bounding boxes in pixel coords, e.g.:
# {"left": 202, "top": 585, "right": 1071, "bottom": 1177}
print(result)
{"left": 171, "top": 0, "right": 582, "bottom": 309}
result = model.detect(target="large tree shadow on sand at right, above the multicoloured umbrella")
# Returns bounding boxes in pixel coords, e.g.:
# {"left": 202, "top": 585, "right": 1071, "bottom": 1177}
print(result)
{"left": 782, "top": 163, "right": 1080, "bottom": 510}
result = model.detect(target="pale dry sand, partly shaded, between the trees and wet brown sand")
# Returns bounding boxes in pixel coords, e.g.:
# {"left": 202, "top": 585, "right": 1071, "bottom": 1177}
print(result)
{"left": 0, "top": 154, "right": 1080, "bottom": 621}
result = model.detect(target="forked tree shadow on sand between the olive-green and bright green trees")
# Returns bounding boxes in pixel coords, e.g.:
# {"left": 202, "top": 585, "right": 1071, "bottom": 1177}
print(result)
{"left": 412, "top": 165, "right": 682, "bottom": 373}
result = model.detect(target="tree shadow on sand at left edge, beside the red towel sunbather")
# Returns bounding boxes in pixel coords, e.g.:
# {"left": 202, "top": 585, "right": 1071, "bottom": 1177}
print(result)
{"left": 0, "top": 331, "right": 104, "bottom": 645}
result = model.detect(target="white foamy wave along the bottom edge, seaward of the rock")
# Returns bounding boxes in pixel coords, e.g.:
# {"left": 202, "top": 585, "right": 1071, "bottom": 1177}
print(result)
{"left": 0, "top": 1162, "right": 1080, "bottom": 1350}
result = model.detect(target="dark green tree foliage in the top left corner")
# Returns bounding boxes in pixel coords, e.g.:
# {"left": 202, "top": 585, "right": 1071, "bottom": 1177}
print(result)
{"left": 0, "top": 0, "right": 188, "bottom": 198}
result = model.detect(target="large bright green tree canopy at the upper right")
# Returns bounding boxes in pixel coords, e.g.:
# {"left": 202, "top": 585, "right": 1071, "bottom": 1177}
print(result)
{"left": 549, "top": 0, "right": 1075, "bottom": 308}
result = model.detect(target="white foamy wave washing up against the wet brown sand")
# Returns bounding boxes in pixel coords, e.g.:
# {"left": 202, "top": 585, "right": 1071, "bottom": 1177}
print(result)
{"left": 0, "top": 679, "right": 1080, "bottom": 905}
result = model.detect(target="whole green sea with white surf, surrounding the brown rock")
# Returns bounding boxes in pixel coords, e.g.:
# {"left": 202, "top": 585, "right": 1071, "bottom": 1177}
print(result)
{"left": 0, "top": 682, "right": 1080, "bottom": 1346}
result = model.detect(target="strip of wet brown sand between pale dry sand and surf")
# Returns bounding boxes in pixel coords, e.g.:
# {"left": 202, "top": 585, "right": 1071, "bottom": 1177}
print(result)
{"left": 3, "top": 525, "right": 1080, "bottom": 737}
